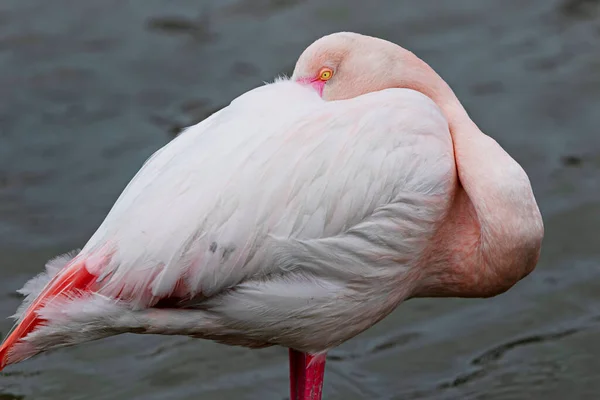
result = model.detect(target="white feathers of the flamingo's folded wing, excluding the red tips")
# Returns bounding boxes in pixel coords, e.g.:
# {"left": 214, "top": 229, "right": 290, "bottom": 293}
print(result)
{"left": 78, "top": 81, "right": 455, "bottom": 308}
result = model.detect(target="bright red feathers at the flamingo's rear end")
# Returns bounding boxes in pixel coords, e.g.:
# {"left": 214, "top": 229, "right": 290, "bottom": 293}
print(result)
{"left": 0, "top": 258, "right": 96, "bottom": 370}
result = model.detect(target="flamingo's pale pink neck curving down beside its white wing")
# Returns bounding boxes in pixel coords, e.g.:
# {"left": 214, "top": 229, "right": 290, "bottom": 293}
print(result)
{"left": 399, "top": 51, "right": 543, "bottom": 297}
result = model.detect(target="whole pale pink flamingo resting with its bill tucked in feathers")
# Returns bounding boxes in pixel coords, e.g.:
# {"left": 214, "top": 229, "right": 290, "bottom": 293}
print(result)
{"left": 0, "top": 32, "right": 544, "bottom": 400}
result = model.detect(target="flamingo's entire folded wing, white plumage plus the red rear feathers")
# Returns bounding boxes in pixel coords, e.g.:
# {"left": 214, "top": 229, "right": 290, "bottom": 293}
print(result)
{"left": 0, "top": 81, "right": 456, "bottom": 362}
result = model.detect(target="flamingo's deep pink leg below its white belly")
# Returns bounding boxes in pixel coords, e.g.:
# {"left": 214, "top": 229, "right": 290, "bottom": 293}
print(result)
{"left": 290, "top": 349, "right": 325, "bottom": 400}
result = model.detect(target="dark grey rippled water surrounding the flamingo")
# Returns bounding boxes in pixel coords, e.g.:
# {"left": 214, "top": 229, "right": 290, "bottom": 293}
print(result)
{"left": 0, "top": 0, "right": 600, "bottom": 400}
